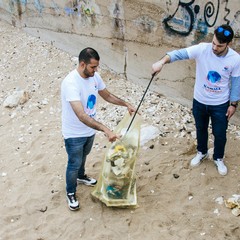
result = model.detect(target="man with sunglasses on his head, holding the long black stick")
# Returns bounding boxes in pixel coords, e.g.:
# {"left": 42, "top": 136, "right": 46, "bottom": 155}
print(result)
{"left": 152, "top": 24, "right": 240, "bottom": 175}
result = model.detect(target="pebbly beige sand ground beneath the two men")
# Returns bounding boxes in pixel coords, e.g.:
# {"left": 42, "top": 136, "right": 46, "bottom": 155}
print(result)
{"left": 0, "top": 22, "right": 240, "bottom": 240}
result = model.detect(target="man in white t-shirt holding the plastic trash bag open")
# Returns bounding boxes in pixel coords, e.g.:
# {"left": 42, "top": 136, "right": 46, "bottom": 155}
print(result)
{"left": 61, "top": 48, "right": 135, "bottom": 210}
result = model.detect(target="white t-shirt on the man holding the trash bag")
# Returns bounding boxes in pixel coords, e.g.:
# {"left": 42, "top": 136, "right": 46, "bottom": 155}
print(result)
{"left": 61, "top": 69, "right": 106, "bottom": 139}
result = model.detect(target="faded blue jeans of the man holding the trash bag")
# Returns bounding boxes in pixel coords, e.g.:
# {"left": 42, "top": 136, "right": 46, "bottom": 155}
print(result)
{"left": 64, "top": 135, "right": 95, "bottom": 193}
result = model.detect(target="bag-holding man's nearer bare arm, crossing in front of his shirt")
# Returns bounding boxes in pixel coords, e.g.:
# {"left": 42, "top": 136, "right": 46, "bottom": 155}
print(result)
{"left": 70, "top": 101, "right": 118, "bottom": 142}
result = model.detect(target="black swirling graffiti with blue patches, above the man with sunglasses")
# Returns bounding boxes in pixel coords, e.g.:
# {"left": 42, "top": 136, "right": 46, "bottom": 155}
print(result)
{"left": 163, "top": 0, "right": 240, "bottom": 38}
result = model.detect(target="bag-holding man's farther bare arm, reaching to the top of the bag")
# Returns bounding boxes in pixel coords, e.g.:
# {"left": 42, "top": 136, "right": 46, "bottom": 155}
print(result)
{"left": 98, "top": 88, "right": 136, "bottom": 115}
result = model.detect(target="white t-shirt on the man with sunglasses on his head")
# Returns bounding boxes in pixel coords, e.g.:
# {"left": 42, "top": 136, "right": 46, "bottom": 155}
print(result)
{"left": 186, "top": 43, "right": 240, "bottom": 105}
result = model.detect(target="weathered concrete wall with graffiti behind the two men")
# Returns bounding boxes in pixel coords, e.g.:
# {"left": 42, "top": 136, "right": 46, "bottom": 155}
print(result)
{"left": 0, "top": 0, "right": 240, "bottom": 112}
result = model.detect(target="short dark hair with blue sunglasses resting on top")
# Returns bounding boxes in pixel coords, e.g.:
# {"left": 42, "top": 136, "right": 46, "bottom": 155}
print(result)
{"left": 214, "top": 24, "right": 234, "bottom": 43}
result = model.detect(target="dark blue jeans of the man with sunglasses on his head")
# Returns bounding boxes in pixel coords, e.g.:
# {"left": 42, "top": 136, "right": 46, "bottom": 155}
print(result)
{"left": 193, "top": 99, "right": 229, "bottom": 160}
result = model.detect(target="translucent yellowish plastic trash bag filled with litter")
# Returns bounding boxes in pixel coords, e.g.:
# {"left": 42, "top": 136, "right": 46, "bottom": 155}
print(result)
{"left": 92, "top": 113, "right": 141, "bottom": 207}
